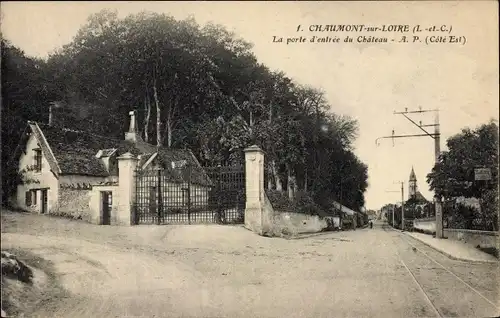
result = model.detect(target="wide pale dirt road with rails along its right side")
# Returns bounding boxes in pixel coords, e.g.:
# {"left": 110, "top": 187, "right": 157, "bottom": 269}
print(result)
{"left": 2, "top": 213, "right": 499, "bottom": 317}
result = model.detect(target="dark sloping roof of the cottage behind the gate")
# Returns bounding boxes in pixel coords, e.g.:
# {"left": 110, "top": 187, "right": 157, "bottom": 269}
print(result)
{"left": 23, "top": 122, "right": 210, "bottom": 184}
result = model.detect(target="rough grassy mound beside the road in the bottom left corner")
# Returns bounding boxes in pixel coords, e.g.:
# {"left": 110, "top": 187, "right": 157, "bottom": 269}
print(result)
{"left": 1, "top": 249, "right": 67, "bottom": 317}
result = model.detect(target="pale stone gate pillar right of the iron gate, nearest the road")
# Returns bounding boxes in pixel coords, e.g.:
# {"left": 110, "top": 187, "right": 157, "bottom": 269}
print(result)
{"left": 245, "top": 145, "right": 265, "bottom": 235}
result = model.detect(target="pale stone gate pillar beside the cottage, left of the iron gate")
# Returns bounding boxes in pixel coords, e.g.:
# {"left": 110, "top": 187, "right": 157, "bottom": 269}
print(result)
{"left": 116, "top": 152, "right": 138, "bottom": 226}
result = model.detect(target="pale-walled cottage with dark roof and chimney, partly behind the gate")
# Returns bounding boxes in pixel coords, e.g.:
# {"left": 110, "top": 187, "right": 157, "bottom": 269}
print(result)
{"left": 13, "top": 112, "right": 211, "bottom": 224}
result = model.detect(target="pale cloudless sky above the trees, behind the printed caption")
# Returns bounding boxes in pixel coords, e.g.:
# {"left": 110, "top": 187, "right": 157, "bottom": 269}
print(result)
{"left": 1, "top": 1, "right": 499, "bottom": 209}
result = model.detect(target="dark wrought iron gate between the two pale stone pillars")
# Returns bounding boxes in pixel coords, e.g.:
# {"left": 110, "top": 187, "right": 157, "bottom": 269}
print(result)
{"left": 133, "top": 164, "right": 245, "bottom": 224}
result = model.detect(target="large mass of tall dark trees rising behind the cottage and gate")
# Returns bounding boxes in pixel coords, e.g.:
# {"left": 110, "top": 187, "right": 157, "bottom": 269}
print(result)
{"left": 2, "top": 10, "right": 368, "bottom": 210}
